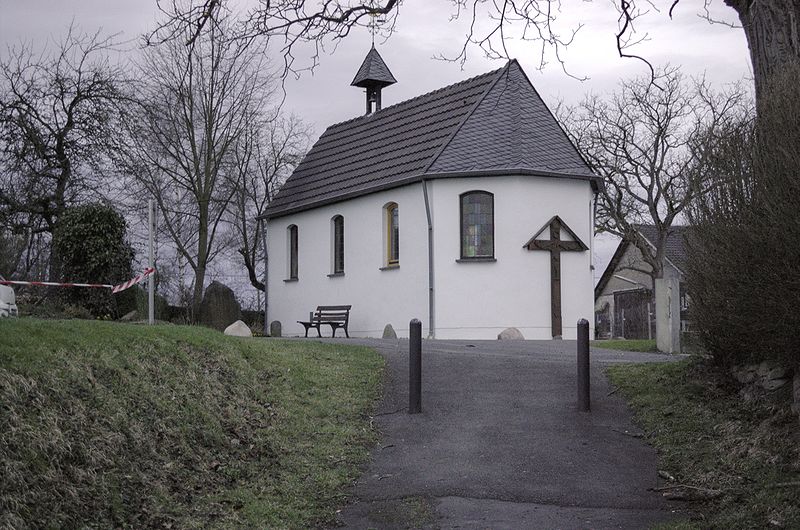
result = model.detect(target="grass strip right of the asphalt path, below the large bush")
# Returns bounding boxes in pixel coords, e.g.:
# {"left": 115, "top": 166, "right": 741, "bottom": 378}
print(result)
{"left": 608, "top": 359, "right": 800, "bottom": 528}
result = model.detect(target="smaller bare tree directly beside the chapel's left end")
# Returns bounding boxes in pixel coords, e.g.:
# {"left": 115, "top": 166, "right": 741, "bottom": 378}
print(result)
{"left": 230, "top": 116, "right": 310, "bottom": 291}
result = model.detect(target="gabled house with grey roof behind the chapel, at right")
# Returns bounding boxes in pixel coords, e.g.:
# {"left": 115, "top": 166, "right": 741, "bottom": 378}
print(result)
{"left": 594, "top": 225, "right": 689, "bottom": 339}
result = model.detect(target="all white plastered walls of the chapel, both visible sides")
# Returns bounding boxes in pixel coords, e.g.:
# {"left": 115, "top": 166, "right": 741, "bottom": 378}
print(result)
{"left": 268, "top": 177, "right": 594, "bottom": 339}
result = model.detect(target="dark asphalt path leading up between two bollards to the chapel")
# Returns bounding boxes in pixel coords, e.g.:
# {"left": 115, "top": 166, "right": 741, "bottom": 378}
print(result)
{"left": 326, "top": 339, "right": 680, "bottom": 529}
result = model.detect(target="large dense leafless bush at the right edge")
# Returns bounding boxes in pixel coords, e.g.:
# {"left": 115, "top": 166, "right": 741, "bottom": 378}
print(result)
{"left": 687, "top": 66, "right": 800, "bottom": 364}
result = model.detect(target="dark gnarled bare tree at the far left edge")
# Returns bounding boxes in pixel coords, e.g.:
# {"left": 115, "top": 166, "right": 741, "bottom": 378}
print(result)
{"left": 0, "top": 28, "right": 124, "bottom": 275}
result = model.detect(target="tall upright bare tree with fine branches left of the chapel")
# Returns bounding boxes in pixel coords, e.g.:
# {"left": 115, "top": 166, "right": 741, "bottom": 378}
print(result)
{"left": 115, "top": 20, "right": 271, "bottom": 318}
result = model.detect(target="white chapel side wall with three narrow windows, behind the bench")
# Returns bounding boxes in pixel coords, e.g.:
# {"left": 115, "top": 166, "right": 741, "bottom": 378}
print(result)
{"left": 267, "top": 184, "right": 428, "bottom": 337}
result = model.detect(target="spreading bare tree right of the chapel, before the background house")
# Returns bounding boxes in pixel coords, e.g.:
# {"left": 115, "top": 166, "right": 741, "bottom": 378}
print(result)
{"left": 560, "top": 67, "right": 749, "bottom": 279}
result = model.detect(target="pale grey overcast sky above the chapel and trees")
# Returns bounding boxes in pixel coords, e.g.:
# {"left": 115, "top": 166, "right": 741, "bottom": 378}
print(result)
{"left": 0, "top": 0, "right": 751, "bottom": 277}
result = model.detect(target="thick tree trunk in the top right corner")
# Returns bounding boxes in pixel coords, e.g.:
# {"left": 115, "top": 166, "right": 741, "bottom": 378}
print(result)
{"left": 725, "top": 0, "right": 800, "bottom": 100}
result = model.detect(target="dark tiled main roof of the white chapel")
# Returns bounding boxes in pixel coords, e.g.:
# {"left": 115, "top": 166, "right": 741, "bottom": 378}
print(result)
{"left": 265, "top": 59, "right": 600, "bottom": 218}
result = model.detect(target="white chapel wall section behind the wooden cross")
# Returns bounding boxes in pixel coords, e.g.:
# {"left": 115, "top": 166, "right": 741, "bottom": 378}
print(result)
{"left": 429, "top": 173, "right": 594, "bottom": 339}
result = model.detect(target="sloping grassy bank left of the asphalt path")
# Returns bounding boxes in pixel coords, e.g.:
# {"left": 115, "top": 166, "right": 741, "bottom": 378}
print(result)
{"left": 0, "top": 318, "right": 383, "bottom": 528}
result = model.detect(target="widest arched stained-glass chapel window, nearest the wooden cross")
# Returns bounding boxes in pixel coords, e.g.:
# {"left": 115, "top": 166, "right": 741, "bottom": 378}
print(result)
{"left": 461, "top": 191, "right": 494, "bottom": 259}
